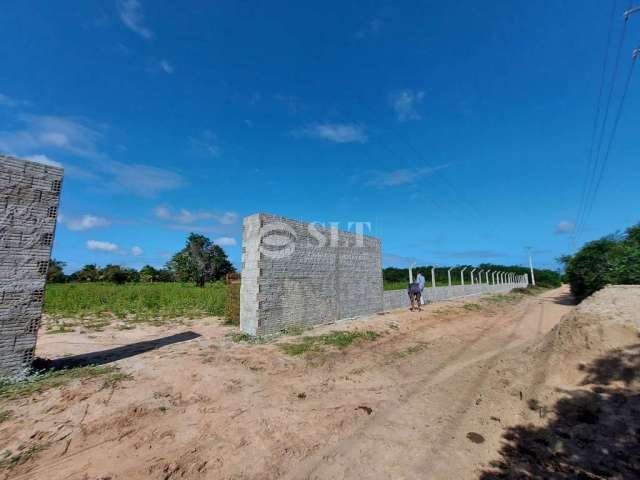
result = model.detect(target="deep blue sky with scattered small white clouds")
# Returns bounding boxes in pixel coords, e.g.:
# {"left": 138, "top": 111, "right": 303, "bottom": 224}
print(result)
{"left": 0, "top": 0, "right": 640, "bottom": 271}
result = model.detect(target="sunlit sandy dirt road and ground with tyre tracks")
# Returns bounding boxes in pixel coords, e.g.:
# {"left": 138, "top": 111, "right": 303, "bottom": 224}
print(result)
{"left": 0, "top": 287, "right": 636, "bottom": 480}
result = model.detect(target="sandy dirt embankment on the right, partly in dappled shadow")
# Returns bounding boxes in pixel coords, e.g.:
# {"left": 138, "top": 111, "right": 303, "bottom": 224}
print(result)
{"left": 481, "top": 286, "right": 640, "bottom": 479}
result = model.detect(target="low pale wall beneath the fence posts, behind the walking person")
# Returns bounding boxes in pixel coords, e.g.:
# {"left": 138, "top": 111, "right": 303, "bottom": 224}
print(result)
{"left": 383, "top": 279, "right": 527, "bottom": 311}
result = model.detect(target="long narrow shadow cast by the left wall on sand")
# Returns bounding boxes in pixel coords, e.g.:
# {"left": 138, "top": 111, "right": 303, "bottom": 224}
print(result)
{"left": 34, "top": 331, "right": 200, "bottom": 370}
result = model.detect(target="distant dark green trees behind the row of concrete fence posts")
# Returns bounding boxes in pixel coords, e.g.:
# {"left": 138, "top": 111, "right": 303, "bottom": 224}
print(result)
{"left": 382, "top": 263, "right": 562, "bottom": 287}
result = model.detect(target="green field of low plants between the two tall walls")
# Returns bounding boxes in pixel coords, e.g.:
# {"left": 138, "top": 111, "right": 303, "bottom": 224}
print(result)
{"left": 44, "top": 282, "right": 227, "bottom": 321}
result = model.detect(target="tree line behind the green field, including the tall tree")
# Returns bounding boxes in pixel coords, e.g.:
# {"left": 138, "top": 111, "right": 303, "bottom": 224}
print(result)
{"left": 47, "top": 233, "right": 235, "bottom": 287}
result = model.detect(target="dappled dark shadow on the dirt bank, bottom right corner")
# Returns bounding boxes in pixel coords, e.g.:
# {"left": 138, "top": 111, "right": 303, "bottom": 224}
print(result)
{"left": 480, "top": 344, "right": 640, "bottom": 480}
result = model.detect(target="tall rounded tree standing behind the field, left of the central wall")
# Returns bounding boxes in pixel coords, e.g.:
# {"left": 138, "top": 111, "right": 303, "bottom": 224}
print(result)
{"left": 167, "top": 233, "right": 235, "bottom": 287}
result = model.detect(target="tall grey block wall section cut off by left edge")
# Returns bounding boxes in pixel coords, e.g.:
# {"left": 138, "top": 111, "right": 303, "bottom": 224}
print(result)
{"left": 0, "top": 155, "right": 63, "bottom": 376}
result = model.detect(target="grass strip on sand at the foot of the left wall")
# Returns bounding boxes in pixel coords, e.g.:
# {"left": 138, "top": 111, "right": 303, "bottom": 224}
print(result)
{"left": 0, "top": 366, "right": 130, "bottom": 400}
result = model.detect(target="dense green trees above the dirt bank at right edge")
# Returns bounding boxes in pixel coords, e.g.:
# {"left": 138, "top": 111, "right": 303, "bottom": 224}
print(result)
{"left": 560, "top": 223, "right": 640, "bottom": 299}
